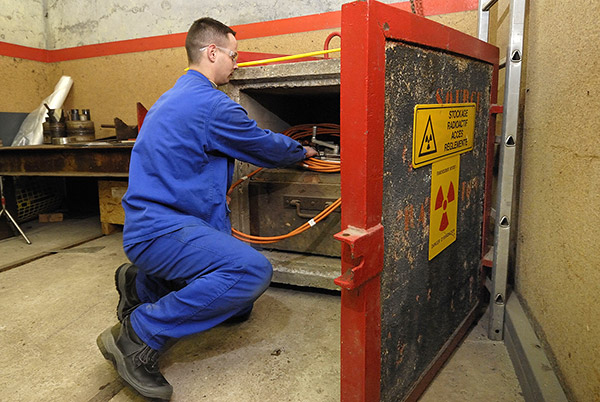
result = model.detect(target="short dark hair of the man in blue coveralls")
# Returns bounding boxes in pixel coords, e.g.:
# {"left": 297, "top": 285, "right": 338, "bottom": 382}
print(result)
{"left": 185, "top": 17, "right": 235, "bottom": 64}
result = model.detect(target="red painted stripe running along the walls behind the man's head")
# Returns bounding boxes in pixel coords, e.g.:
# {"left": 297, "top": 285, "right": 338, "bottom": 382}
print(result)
{"left": 0, "top": 0, "right": 478, "bottom": 63}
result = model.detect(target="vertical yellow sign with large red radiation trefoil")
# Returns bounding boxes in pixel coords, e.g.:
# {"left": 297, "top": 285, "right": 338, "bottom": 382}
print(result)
{"left": 429, "top": 155, "right": 460, "bottom": 260}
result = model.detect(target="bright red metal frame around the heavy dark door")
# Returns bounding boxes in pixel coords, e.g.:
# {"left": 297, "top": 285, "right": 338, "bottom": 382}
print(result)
{"left": 335, "top": 0, "right": 498, "bottom": 402}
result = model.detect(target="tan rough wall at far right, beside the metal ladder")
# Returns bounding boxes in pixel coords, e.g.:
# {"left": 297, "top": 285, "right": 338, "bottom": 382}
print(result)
{"left": 516, "top": 0, "right": 600, "bottom": 402}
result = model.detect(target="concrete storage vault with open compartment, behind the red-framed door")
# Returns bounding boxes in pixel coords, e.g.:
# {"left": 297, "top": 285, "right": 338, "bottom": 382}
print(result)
{"left": 225, "top": 59, "right": 341, "bottom": 289}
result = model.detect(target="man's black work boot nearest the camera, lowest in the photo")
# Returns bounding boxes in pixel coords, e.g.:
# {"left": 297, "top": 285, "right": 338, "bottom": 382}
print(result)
{"left": 96, "top": 316, "right": 173, "bottom": 401}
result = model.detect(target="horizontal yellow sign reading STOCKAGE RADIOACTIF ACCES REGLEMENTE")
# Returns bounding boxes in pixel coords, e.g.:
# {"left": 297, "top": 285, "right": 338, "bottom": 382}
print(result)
{"left": 412, "top": 103, "right": 475, "bottom": 168}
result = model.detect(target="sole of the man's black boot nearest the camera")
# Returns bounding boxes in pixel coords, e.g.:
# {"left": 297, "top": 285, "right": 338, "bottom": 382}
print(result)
{"left": 96, "top": 328, "right": 173, "bottom": 401}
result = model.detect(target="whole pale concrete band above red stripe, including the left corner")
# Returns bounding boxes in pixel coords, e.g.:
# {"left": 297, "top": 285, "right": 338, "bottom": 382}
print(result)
{"left": 0, "top": 0, "right": 398, "bottom": 49}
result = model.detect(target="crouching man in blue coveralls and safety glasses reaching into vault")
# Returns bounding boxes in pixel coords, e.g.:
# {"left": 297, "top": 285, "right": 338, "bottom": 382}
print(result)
{"left": 97, "top": 18, "right": 316, "bottom": 400}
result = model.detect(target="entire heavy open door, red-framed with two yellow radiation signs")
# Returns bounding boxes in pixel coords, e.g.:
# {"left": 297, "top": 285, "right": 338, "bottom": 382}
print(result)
{"left": 336, "top": 1, "right": 498, "bottom": 402}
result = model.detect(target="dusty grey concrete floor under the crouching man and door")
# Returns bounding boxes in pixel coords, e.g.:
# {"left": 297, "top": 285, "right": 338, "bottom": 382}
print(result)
{"left": 0, "top": 217, "right": 523, "bottom": 402}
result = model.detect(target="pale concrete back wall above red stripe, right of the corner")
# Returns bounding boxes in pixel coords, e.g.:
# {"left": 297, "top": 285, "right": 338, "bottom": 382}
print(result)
{"left": 48, "top": 0, "right": 397, "bottom": 49}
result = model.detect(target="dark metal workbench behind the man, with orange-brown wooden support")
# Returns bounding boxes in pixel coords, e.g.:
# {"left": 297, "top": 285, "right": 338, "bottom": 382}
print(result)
{"left": 0, "top": 142, "right": 133, "bottom": 234}
